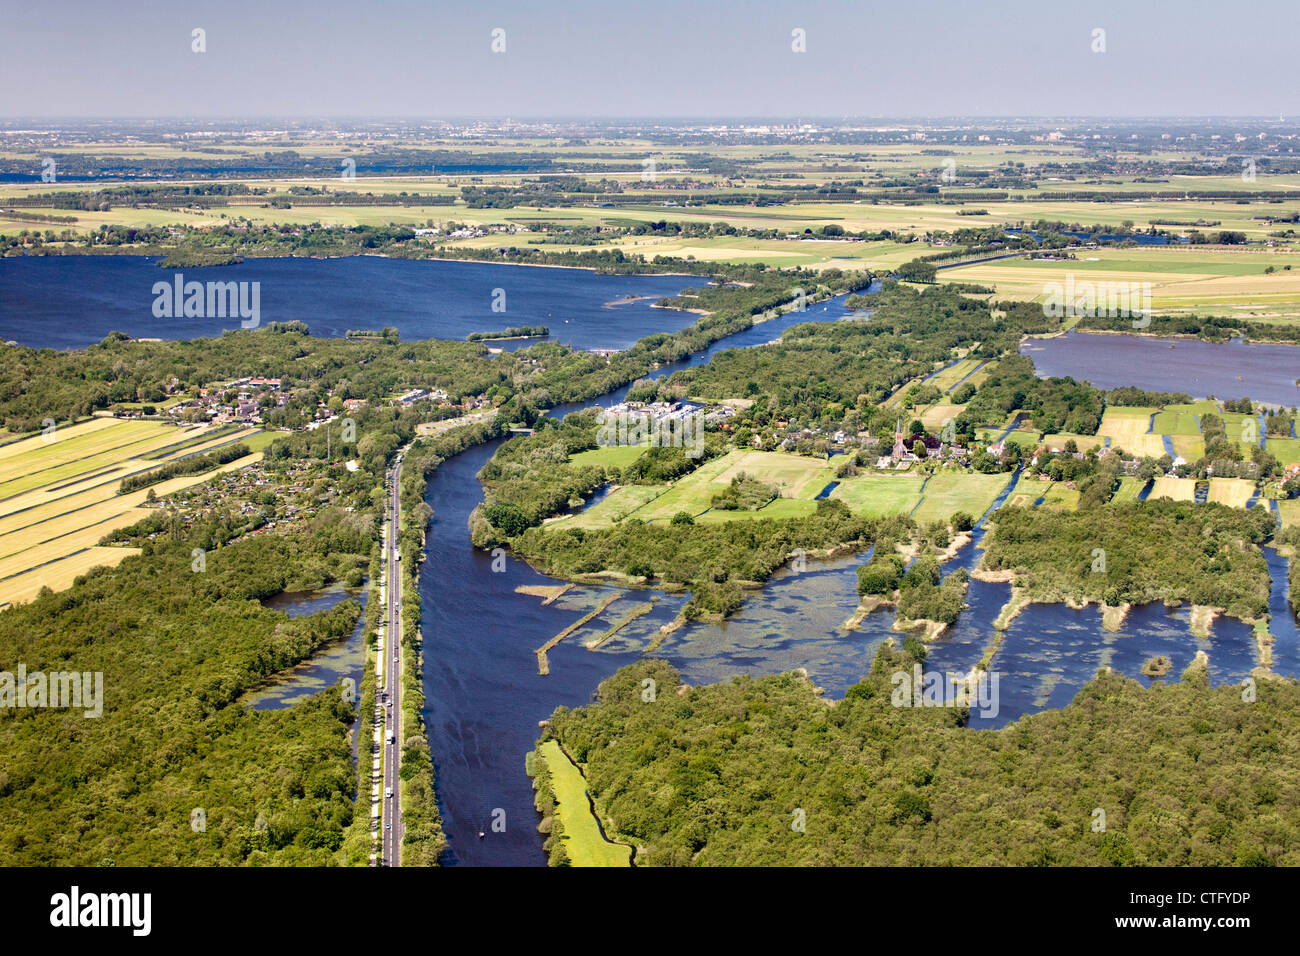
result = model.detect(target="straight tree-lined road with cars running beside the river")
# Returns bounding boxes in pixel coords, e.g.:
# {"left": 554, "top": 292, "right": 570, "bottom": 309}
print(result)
{"left": 380, "top": 455, "right": 402, "bottom": 866}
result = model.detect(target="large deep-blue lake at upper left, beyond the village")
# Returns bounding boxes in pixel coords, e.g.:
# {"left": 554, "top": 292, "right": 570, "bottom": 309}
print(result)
{"left": 0, "top": 255, "right": 707, "bottom": 349}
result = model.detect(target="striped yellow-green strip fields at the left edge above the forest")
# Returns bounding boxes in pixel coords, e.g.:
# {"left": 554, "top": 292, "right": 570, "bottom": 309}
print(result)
{"left": 0, "top": 418, "right": 261, "bottom": 606}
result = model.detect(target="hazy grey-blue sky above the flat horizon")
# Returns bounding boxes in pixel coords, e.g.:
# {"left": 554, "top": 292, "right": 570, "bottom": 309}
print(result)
{"left": 0, "top": 0, "right": 1300, "bottom": 118}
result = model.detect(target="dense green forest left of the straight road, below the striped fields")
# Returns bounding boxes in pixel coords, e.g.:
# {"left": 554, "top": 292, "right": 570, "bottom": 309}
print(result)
{"left": 0, "top": 512, "right": 374, "bottom": 866}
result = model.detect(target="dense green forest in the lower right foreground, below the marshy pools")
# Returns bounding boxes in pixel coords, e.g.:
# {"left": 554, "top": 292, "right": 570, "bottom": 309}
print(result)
{"left": 543, "top": 650, "right": 1300, "bottom": 866}
